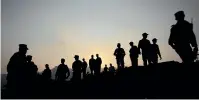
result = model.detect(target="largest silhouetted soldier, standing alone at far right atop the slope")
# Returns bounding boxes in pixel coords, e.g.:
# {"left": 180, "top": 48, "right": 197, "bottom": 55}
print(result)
{"left": 169, "top": 11, "right": 198, "bottom": 63}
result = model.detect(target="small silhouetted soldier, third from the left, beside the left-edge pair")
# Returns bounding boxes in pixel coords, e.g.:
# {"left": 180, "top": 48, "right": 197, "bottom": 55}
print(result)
{"left": 42, "top": 64, "right": 51, "bottom": 81}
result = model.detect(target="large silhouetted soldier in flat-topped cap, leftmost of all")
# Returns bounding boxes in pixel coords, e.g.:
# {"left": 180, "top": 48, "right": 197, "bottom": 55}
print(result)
{"left": 7, "top": 44, "right": 28, "bottom": 88}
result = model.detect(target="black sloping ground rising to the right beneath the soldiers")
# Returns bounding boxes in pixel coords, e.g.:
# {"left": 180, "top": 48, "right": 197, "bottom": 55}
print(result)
{"left": 2, "top": 62, "right": 199, "bottom": 99}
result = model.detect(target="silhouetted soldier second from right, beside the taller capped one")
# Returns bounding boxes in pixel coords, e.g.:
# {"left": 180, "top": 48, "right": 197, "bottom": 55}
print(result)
{"left": 151, "top": 38, "right": 162, "bottom": 64}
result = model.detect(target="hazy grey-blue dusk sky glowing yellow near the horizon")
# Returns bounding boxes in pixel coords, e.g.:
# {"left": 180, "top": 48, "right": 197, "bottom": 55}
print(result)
{"left": 1, "top": 0, "right": 199, "bottom": 73}
